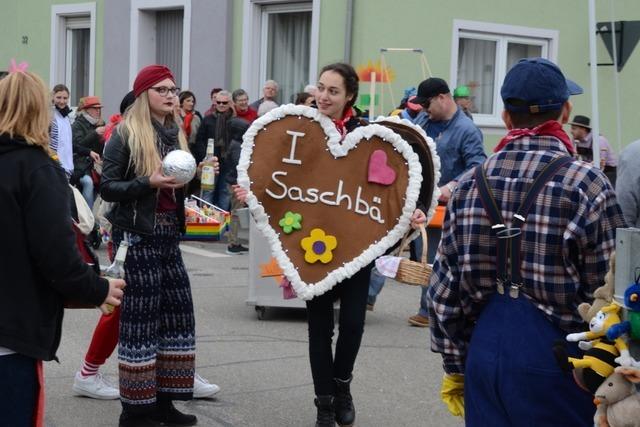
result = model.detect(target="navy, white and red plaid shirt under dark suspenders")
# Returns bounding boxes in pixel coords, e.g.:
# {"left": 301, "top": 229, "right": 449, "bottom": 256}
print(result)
{"left": 428, "top": 136, "right": 626, "bottom": 373}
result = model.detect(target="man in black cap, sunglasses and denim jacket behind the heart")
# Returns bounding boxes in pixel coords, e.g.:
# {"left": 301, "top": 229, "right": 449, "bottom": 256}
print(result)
{"left": 408, "top": 77, "right": 487, "bottom": 327}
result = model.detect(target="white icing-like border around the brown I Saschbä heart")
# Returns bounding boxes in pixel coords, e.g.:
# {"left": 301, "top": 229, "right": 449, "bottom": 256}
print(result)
{"left": 237, "top": 104, "right": 424, "bottom": 300}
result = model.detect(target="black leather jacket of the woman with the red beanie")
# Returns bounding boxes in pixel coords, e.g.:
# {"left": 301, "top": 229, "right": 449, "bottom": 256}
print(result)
{"left": 100, "top": 123, "right": 185, "bottom": 235}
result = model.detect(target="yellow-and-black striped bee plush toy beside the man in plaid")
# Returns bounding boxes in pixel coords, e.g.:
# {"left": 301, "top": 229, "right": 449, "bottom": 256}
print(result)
{"left": 553, "top": 304, "right": 630, "bottom": 393}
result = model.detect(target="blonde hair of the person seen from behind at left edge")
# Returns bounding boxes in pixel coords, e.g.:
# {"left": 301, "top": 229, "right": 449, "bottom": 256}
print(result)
{"left": 0, "top": 71, "right": 51, "bottom": 147}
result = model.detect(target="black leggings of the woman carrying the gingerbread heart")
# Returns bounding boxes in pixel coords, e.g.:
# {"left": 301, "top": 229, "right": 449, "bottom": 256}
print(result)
{"left": 307, "top": 264, "right": 373, "bottom": 396}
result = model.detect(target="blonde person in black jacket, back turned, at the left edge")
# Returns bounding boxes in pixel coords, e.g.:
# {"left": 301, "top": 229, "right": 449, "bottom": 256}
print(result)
{"left": 0, "top": 62, "right": 124, "bottom": 426}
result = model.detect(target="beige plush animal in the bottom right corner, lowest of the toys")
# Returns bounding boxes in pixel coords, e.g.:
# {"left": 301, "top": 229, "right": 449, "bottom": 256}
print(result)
{"left": 594, "top": 373, "right": 640, "bottom": 427}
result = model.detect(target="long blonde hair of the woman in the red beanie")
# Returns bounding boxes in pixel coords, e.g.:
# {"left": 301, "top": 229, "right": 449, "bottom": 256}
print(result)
{"left": 118, "top": 91, "right": 189, "bottom": 176}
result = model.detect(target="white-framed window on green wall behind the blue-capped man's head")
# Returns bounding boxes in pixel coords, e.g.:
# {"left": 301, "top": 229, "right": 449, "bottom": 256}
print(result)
{"left": 451, "top": 21, "right": 558, "bottom": 126}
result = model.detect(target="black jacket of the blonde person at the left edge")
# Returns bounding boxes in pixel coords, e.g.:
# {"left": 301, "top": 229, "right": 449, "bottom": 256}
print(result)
{"left": 0, "top": 135, "right": 109, "bottom": 360}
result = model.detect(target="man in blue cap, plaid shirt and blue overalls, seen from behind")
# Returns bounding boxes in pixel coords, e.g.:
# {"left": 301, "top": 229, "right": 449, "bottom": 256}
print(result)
{"left": 427, "top": 58, "right": 625, "bottom": 427}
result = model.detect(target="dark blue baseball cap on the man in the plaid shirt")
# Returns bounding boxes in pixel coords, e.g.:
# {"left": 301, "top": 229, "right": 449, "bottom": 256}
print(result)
{"left": 500, "top": 58, "right": 583, "bottom": 114}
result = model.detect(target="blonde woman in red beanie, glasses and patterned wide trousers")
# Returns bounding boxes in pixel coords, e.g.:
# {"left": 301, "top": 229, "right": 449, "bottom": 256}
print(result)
{"left": 101, "top": 65, "right": 205, "bottom": 427}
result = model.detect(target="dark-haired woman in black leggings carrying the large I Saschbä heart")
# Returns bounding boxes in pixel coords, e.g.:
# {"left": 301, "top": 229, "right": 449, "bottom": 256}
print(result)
{"left": 234, "top": 63, "right": 426, "bottom": 427}
